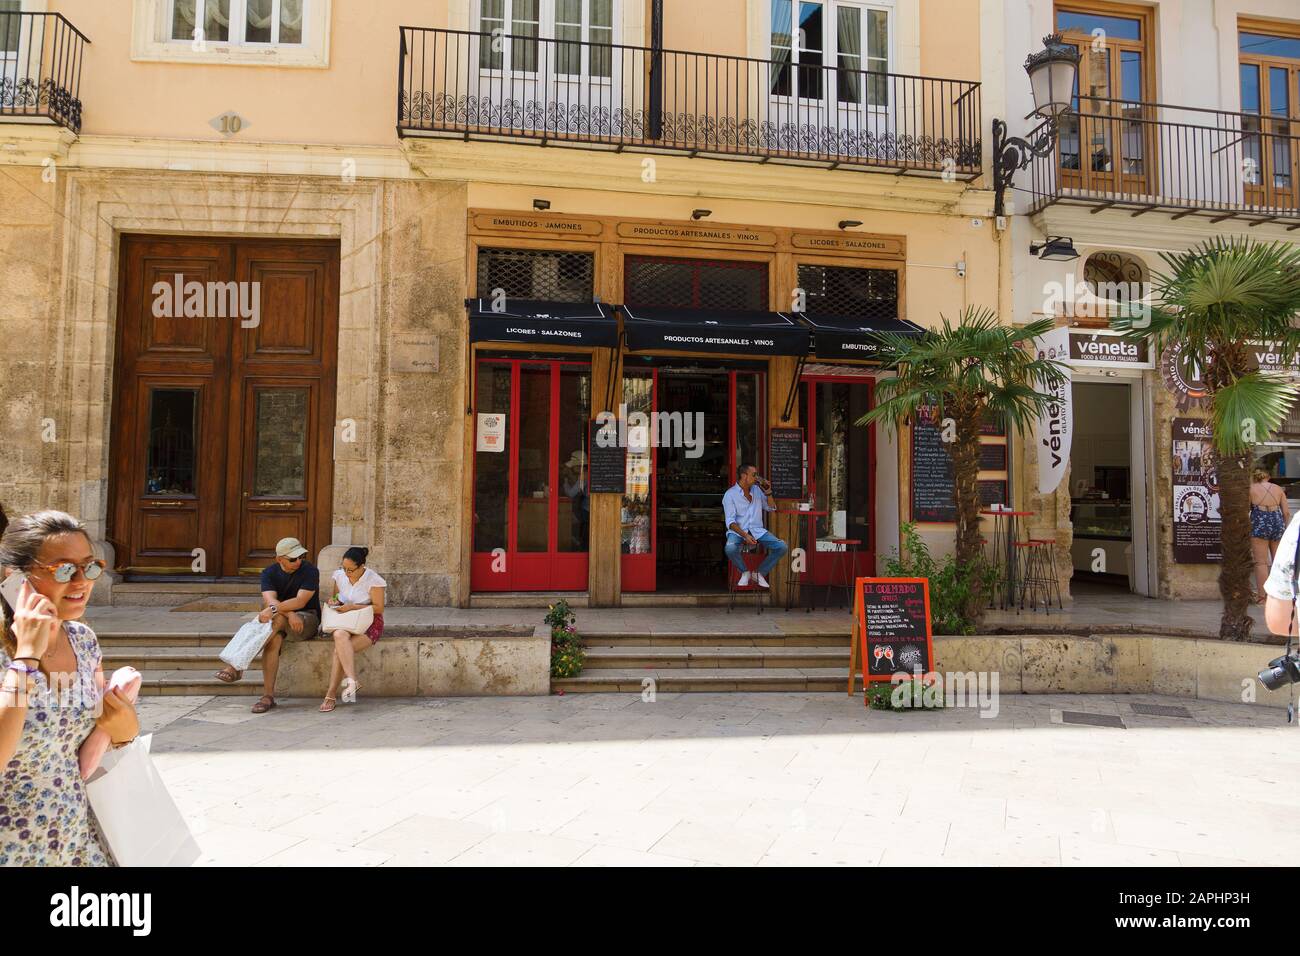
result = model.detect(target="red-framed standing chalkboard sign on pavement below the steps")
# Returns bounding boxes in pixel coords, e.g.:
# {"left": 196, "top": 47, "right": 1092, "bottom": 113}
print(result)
{"left": 857, "top": 578, "right": 935, "bottom": 682}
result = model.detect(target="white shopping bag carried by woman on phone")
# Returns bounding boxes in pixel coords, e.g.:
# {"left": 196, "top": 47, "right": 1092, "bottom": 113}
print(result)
{"left": 86, "top": 734, "right": 199, "bottom": 866}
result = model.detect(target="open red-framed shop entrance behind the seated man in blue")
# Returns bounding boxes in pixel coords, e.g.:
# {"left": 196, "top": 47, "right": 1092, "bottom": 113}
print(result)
{"left": 621, "top": 364, "right": 767, "bottom": 593}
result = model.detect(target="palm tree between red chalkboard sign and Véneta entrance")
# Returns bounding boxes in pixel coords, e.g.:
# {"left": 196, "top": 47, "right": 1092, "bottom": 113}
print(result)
{"left": 858, "top": 307, "right": 1065, "bottom": 626}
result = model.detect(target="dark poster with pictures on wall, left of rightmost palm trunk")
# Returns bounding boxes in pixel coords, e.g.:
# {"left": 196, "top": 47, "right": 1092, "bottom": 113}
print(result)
{"left": 1171, "top": 419, "right": 1223, "bottom": 564}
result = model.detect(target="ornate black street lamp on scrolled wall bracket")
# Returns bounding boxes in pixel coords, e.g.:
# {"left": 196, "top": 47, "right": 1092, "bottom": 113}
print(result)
{"left": 993, "top": 34, "right": 1079, "bottom": 216}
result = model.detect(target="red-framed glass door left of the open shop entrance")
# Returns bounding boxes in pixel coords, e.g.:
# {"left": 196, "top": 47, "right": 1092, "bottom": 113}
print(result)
{"left": 469, "top": 358, "right": 592, "bottom": 591}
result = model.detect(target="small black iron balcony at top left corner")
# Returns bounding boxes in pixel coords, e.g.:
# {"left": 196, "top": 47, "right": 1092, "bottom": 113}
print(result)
{"left": 0, "top": 12, "right": 90, "bottom": 133}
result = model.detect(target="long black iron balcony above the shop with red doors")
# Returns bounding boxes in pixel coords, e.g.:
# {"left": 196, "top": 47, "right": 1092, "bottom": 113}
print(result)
{"left": 398, "top": 27, "right": 982, "bottom": 181}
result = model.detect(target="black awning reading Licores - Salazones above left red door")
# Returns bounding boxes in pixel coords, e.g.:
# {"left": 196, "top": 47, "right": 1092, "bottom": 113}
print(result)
{"left": 465, "top": 299, "right": 619, "bottom": 349}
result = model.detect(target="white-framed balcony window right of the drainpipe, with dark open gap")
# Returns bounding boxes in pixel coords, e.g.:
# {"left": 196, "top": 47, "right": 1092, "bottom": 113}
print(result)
{"left": 770, "top": 0, "right": 891, "bottom": 107}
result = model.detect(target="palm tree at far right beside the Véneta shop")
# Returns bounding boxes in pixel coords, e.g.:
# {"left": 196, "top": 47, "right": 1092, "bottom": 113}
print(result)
{"left": 1112, "top": 237, "right": 1300, "bottom": 641}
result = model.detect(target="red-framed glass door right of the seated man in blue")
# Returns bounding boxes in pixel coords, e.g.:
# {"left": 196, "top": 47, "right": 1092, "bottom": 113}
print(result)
{"left": 800, "top": 376, "right": 876, "bottom": 584}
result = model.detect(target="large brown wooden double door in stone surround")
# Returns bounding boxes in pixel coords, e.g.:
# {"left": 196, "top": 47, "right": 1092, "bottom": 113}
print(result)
{"left": 109, "top": 235, "right": 339, "bottom": 578}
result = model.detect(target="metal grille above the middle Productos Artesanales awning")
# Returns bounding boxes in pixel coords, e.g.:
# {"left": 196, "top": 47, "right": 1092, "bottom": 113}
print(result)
{"left": 623, "top": 256, "right": 767, "bottom": 312}
